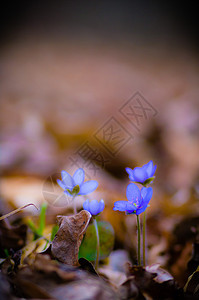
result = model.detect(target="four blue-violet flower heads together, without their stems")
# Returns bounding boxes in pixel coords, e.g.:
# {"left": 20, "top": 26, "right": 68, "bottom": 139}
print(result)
{"left": 57, "top": 160, "right": 157, "bottom": 216}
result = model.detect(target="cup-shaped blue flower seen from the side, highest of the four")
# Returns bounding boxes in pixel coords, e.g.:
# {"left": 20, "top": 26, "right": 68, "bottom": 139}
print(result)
{"left": 126, "top": 160, "right": 157, "bottom": 185}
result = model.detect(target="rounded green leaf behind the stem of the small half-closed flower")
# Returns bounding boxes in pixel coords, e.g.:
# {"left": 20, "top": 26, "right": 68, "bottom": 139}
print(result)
{"left": 79, "top": 221, "right": 114, "bottom": 261}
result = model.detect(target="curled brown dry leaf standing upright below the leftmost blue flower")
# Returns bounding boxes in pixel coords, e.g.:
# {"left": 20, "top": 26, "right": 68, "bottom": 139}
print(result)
{"left": 51, "top": 210, "right": 91, "bottom": 266}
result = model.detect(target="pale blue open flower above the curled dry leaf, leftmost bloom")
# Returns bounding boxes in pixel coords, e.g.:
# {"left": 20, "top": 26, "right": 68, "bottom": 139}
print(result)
{"left": 57, "top": 168, "right": 98, "bottom": 195}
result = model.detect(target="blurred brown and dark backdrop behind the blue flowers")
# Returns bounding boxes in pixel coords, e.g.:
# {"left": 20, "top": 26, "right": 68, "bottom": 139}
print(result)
{"left": 0, "top": 1, "right": 199, "bottom": 284}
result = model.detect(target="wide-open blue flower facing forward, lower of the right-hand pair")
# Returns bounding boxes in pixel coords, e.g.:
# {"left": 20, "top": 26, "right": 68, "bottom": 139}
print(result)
{"left": 113, "top": 183, "right": 153, "bottom": 215}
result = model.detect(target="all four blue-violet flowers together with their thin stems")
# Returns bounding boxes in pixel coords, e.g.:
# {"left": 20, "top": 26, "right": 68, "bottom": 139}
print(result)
{"left": 57, "top": 161, "right": 156, "bottom": 269}
